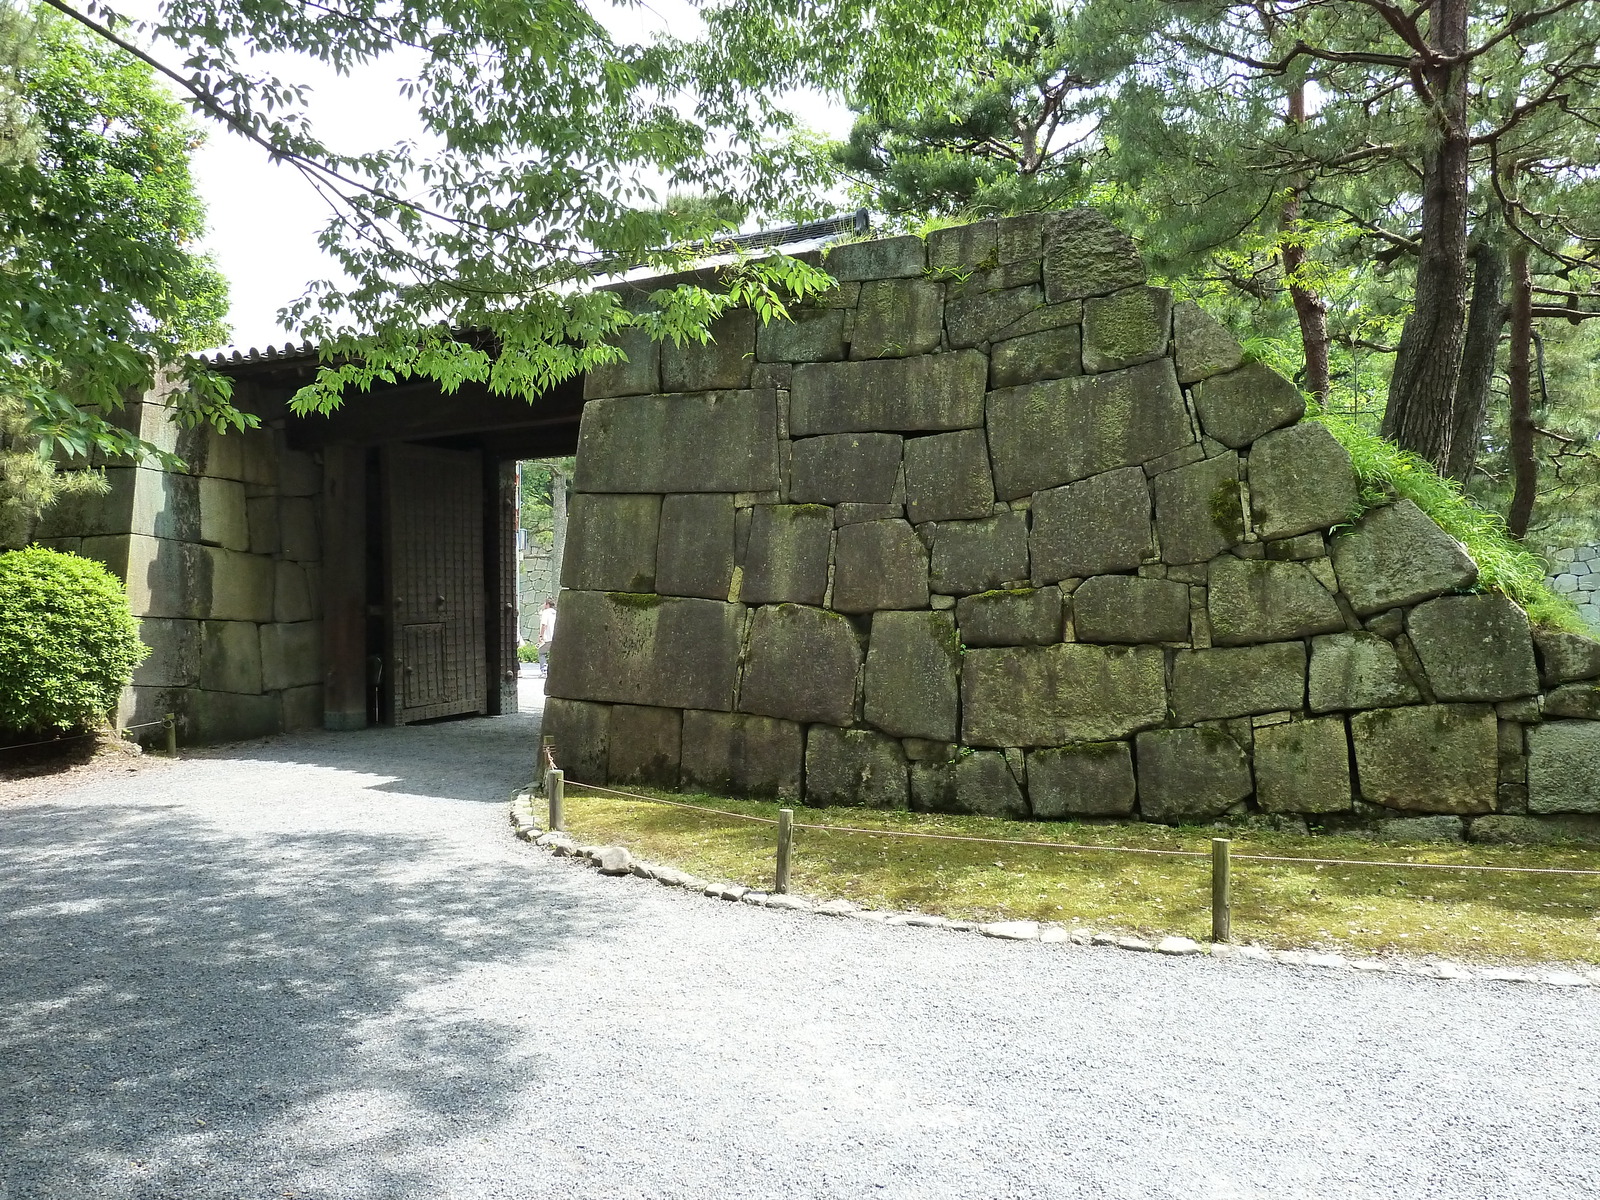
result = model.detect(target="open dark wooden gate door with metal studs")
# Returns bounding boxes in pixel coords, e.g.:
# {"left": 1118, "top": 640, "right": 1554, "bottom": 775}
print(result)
{"left": 382, "top": 445, "right": 488, "bottom": 725}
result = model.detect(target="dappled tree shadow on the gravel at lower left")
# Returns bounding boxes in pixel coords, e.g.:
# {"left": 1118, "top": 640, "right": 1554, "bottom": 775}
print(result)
{"left": 0, "top": 784, "right": 585, "bottom": 1200}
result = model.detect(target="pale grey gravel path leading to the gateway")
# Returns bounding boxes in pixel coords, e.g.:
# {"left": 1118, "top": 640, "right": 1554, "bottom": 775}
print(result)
{"left": 0, "top": 700, "right": 1600, "bottom": 1200}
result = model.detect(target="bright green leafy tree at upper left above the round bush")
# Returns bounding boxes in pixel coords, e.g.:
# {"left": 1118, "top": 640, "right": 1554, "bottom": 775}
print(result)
{"left": 0, "top": 5, "right": 251, "bottom": 458}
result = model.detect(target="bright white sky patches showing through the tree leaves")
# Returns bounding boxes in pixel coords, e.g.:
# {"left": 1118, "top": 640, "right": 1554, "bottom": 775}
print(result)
{"left": 159, "top": 0, "right": 850, "bottom": 347}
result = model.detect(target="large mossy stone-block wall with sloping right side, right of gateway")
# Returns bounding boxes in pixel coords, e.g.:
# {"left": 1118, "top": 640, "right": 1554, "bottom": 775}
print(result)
{"left": 546, "top": 210, "right": 1600, "bottom": 838}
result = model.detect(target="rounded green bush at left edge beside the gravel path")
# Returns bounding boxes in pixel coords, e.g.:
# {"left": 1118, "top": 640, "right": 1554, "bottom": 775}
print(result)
{"left": 0, "top": 547, "right": 149, "bottom": 734}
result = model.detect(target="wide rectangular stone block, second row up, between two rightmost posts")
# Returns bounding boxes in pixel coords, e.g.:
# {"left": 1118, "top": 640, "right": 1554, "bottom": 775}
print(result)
{"left": 962, "top": 643, "right": 1166, "bottom": 746}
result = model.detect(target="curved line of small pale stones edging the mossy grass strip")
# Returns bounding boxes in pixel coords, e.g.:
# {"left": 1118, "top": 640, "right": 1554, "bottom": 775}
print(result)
{"left": 510, "top": 787, "right": 1600, "bottom": 987}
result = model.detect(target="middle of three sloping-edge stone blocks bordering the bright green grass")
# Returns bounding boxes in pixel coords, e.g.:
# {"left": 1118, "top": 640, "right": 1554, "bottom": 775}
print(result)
{"left": 1333, "top": 499, "right": 1478, "bottom": 616}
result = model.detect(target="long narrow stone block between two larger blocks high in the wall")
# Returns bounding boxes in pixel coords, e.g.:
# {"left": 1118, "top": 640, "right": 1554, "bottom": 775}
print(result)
{"left": 787, "top": 350, "right": 989, "bottom": 438}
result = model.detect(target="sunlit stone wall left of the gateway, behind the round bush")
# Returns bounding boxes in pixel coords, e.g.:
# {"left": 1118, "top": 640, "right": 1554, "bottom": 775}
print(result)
{"left": 37, "top": 382, "right": 322, "bottom": 742}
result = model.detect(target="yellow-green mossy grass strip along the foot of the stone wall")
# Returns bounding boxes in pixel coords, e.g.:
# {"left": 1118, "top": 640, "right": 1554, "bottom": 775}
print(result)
{"left": 566, "top": 787, "right": 1600, "bottom": 963}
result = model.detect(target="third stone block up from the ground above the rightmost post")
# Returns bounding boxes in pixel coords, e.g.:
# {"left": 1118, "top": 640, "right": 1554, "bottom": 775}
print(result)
{"left": 1208, "top": 554, "right": 1344, "bottom": 646}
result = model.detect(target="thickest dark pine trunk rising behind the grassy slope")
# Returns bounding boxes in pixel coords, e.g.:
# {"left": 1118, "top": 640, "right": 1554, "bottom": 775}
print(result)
{"left": 1382, "top": 0, "right": 1470, "bottom": 469}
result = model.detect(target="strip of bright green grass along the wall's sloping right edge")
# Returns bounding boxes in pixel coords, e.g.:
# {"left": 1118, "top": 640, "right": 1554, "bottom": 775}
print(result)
{"left": 1310, "top": 413, "right": 1589, "bottom": 634}
